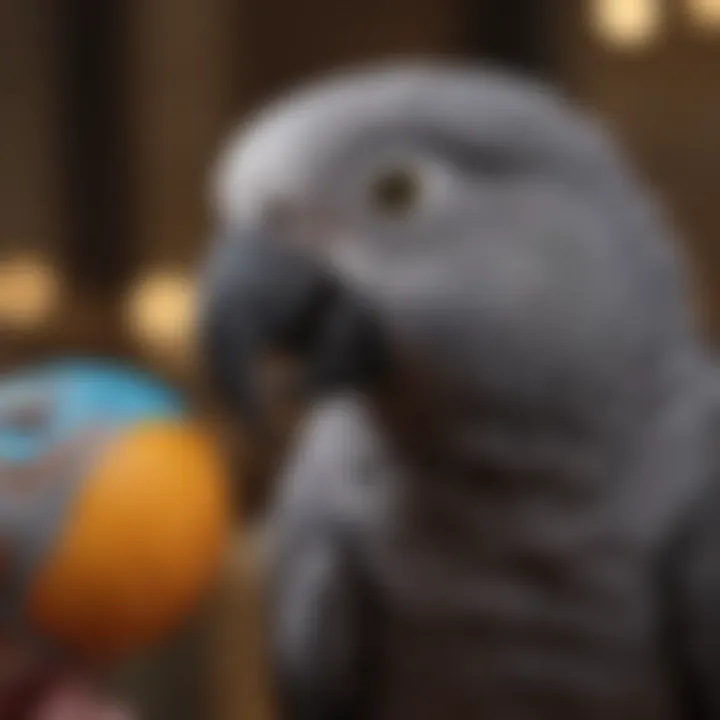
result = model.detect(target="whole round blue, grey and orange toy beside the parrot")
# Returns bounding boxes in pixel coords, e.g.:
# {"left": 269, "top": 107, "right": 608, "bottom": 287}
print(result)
{"left": 0, "top": 361, "right": 229, "bottom": 659}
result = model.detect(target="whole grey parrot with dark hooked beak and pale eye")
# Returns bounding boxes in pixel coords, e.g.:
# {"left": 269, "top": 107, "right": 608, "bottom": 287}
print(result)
{"left": 200, "top": 63, "right": 720, "bottom": 720}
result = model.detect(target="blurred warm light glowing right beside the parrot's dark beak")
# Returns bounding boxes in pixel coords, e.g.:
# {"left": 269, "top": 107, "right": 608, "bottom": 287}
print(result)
{"left": 127, "top": 270, "right": 195, "bottom": 354}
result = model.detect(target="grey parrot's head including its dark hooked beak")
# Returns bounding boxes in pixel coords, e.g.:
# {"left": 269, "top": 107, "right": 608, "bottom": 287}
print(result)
{"left": 201, "top": 63, "right": 693, "bottom": 442}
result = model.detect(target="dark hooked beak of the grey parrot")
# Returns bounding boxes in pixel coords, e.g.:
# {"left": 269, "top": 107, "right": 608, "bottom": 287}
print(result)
{"left": 200, "top": 230, "right": 388, "bottom": 433}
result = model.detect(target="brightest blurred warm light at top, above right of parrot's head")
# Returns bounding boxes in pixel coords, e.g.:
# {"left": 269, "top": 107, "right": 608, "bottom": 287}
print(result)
{"left": 590, "top": 0, "right": 663, "bottom": 49}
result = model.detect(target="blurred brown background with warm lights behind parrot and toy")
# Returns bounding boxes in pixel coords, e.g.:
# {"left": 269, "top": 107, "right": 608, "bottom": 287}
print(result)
{"left": 0, "top": 0, "right": 720, "bottom": 720}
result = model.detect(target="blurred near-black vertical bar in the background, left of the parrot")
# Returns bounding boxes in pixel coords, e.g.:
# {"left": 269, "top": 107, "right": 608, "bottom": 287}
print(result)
{"left": 58, "top": 0, "right": 134, "bottom": 302}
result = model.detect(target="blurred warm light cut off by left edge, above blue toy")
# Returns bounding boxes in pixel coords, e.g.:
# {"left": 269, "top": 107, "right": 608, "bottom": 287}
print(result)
{"left": 0, "top": 255, "right": 60, "bottom": 329}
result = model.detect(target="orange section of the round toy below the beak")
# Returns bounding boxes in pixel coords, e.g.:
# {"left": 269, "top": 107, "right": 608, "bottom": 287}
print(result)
{"left": 28, "top": 419, "right": 229, "bottom": 660}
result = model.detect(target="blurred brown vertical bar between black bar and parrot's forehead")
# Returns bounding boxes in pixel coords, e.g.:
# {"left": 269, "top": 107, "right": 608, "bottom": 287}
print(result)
{"left": 127, "top": 0, "right": 238, "bottom": 272}
